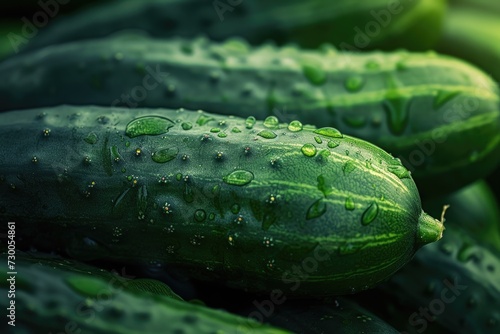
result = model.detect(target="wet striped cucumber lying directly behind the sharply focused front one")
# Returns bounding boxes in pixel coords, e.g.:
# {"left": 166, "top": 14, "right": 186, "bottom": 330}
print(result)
{"left": 0, "top": 37, "right": 500, "bottom": 196}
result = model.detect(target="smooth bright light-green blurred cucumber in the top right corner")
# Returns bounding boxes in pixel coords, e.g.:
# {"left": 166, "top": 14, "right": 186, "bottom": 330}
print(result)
{"left": 436, "top": 7, "right": 500, "bottom": 82}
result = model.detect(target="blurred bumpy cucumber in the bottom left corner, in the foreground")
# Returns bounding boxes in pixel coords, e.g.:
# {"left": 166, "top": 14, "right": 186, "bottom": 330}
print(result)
{"left": 0, "top": 253, "right": 290, "bottom": 334}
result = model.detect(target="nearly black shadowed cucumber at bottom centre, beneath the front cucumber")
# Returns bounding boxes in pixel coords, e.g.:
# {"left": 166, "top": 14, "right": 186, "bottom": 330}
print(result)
{"left": 240, "top": 297, "right": 399, "bottom": 334}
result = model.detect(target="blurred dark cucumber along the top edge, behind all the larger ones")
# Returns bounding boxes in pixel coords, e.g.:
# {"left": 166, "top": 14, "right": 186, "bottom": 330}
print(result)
{"left": 19, "top": 0, "right": 446, "bottom": 50}
